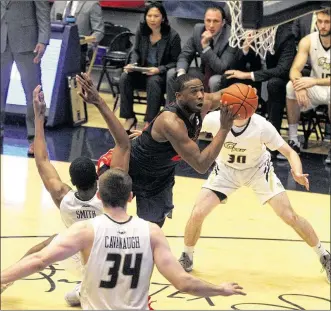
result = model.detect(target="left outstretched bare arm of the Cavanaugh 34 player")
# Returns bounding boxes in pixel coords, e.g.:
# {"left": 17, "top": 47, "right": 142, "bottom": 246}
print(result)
{"left": 1, "top": 221, "right": 94, "bottom": 284}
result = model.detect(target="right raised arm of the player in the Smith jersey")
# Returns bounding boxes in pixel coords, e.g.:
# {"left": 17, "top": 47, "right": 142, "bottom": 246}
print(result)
{"left": 76, "top": 73, "right": 131, "bottom": 172}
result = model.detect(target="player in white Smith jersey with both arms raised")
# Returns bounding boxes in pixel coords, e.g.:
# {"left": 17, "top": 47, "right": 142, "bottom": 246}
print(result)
{"left": 3, "top": 74, "right": 130, "bottom": 305}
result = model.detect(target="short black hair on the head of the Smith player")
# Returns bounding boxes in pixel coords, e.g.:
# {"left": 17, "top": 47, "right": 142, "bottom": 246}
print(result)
{"left": 69, "top": 157, "right": 98, "bottom": 190}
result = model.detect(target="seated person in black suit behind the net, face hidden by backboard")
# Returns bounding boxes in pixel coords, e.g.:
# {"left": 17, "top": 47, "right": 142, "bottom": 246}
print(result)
{"left": 225, "top": 24, "right": 296, "bottom": 136}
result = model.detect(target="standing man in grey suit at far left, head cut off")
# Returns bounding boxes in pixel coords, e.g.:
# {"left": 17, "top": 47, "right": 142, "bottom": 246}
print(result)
{"left": 0, "top": 0, "right": 51, "bottom": 156}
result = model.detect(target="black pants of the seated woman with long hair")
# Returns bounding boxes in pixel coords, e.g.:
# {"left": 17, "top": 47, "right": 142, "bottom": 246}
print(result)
{"left": 120, "top": 72, "right": 166, "bottom": 122}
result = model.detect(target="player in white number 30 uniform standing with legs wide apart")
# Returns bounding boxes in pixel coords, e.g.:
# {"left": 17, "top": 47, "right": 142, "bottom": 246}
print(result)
{"left": 180, "top": 112, "right": 330, "bottom": 282}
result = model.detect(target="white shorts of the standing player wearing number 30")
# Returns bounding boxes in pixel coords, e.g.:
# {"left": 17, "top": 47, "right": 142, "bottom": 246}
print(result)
{"left": 202, "top": 158, "right": 285, "bottom": 204}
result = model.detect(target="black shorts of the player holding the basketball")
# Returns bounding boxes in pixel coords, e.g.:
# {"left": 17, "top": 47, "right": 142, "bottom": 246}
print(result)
{"left": 135, "top": 184, "right": 174, "bottom": 223}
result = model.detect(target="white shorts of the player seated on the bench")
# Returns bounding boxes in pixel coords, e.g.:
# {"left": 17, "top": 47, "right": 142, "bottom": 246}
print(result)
{"left": 286, "top": 81, "right": 330, "bottom": 111}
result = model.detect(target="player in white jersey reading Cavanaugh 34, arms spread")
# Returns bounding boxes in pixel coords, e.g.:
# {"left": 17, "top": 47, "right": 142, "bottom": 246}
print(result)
{"left": 1, "top": 169, "right": 245, "bottom": 310}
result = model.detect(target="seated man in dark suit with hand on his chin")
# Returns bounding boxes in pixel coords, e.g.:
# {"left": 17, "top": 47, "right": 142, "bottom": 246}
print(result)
{"left": 167, "top": 7, "right": 237, "bottom": 102}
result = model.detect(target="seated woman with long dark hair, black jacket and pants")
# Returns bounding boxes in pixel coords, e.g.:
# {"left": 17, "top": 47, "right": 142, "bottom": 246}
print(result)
{"left": 120, "top": 2, "right": 181, "bottom": 133}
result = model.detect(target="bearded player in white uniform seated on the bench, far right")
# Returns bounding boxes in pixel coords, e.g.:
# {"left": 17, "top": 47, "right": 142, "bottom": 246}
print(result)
{"left": 286, "top": 9, "right": 331, "bottom": 164}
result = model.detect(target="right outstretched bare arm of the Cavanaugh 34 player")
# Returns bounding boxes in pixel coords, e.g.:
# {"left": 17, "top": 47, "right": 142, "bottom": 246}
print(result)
{"left": 150, "top": 224, "right": 246, "bottom": 297}
